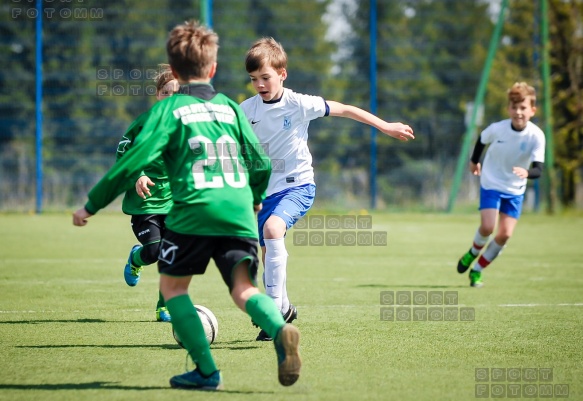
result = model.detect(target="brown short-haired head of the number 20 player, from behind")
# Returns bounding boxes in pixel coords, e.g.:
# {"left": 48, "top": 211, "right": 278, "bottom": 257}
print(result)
{"left": 166, "top": 21, "right": 219, "bottom": 81}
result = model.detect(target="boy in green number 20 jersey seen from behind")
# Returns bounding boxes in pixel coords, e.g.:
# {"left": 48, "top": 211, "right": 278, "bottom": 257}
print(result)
{"left": 73, "top": 22, "right": 301, "bottom": 390}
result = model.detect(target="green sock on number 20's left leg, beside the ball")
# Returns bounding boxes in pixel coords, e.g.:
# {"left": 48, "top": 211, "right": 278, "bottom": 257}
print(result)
{"left": 166, "top": 294, "right": 217, "bottom": 376}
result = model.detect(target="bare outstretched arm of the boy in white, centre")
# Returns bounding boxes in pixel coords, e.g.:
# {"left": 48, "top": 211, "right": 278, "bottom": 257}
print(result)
{"left": 326, "top": 100, "right": 415, "bottom": 141}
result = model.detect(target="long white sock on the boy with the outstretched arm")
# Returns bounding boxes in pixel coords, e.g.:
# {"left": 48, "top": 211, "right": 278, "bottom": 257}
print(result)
{"left": 264, "top": 238, "right": 289, "bottom": 313}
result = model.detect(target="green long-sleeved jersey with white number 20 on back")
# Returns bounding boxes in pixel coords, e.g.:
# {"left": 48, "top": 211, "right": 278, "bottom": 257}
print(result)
{"left": 85, "top": 84, "right": 271, "bottom": 238}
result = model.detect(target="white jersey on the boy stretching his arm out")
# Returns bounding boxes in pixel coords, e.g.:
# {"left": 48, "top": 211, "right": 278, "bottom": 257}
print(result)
{"left": 241, "top": 89, "right": 327, "bottom": 196}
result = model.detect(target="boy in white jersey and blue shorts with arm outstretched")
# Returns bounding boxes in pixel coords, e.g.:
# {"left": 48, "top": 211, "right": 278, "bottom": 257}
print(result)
{"left": 241, "top": 38, "right": 414, "bottom": 341}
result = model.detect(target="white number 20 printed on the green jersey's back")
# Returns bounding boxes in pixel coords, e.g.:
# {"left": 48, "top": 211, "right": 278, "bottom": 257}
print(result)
{"left": 188, "top": 135, "right": 247, "bottom": 189}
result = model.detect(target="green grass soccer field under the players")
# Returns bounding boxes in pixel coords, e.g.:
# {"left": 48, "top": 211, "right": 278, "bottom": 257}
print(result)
{"left": 0, "top": 212, "right": 583, "bottom": 401}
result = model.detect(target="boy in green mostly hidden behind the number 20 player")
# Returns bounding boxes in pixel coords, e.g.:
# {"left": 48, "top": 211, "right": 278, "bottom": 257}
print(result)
{"left": 116, "top": 64, "right": 179, "bottom": 322}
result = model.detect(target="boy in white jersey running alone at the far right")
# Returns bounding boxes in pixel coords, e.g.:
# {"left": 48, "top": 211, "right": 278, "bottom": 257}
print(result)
{"left": 457, "top": 82, "right": 545, "bottom": 288}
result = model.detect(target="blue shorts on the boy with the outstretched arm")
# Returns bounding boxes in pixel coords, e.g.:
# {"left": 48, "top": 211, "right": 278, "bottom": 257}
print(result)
{"left": 257, "top": 184, "right": 316, "bottom": 246}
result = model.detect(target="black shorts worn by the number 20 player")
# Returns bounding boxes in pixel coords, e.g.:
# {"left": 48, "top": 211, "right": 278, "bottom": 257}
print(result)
{"left": 158, "top": 230, "right": 259, "bottom": 292}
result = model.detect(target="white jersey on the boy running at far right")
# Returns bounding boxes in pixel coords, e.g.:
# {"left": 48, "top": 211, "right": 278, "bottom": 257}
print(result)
{"left": 480, "top": 119, "right": 545, "bottom": 195}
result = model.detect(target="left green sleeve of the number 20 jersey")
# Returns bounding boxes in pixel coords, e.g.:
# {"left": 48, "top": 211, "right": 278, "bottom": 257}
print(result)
{"left": 85, "top": 105, "right": 170, "bottom": 214}
